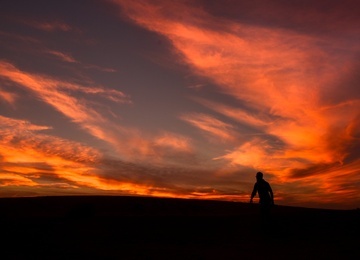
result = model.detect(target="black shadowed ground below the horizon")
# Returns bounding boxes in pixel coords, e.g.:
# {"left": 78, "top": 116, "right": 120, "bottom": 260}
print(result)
{"left": 0, "top": 197, "right": 360, "bottom": 260}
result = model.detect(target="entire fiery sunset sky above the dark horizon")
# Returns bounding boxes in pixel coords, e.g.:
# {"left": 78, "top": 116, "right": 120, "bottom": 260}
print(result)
{"left": 0, "top": 0, "right": 360, "bottom": 209}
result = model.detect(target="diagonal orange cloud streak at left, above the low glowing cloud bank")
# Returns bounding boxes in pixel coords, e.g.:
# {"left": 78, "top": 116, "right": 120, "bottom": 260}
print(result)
{"left": 0, "top": 62, "right": 191, "bottom": 165}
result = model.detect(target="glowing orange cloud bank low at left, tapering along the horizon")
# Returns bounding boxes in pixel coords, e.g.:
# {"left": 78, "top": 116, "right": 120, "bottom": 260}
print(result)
{"left": 0, "top": 116, "right": 191, "bottom": 196}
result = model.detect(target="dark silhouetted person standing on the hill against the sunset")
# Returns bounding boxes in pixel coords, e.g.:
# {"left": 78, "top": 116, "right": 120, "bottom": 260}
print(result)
{"left": 250, "top": 172, "right": 274, "bottom": 224}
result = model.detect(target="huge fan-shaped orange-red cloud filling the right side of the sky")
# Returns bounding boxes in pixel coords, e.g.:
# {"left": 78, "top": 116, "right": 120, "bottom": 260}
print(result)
{"left": 112, "top": 0, "right": 360, "bottom": 207}
